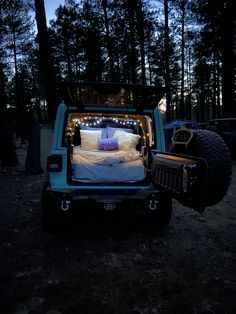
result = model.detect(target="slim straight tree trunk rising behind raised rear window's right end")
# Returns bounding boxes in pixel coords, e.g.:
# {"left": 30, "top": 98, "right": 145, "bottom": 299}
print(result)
{"left": 164, "top": 0, "right": 171, "bottom": 121}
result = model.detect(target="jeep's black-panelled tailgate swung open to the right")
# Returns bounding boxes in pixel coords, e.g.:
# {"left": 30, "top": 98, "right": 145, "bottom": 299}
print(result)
{"left": 151, "top": 151, "right": 207, "bottom": 212}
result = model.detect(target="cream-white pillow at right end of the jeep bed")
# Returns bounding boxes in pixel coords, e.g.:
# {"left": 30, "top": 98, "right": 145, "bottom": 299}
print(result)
{"left": 113, "top": 130, "right": 141, "bottom": 150}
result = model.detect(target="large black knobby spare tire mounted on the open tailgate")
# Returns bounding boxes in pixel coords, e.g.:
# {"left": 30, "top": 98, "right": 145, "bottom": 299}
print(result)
{"left": 170, "top": 129, "right": 232, "bottom": 206}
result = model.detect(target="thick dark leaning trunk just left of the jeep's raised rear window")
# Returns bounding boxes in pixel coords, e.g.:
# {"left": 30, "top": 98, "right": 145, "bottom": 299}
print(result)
{"left": 35, "top": 0, "right": 57, "bottom": 124}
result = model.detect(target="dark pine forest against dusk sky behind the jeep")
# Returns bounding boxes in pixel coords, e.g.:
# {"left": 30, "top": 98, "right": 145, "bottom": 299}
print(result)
{"left": 0, "top": 0, "right": 236, "bottom": 165}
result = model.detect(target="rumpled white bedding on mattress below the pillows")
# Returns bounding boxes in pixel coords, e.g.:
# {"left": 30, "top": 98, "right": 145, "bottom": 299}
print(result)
{"left": 72, "top": 146, "right": 146, "bottom": 183}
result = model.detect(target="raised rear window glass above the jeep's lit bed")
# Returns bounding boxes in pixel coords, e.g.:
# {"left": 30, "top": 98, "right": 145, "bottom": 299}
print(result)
{"left": 60, "top": 81, "right": 165, "bottom": 113}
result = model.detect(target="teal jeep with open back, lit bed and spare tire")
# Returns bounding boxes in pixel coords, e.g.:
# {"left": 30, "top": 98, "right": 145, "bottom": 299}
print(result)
{"left": 41, "top": 82, "right": 231, "bottom": 229}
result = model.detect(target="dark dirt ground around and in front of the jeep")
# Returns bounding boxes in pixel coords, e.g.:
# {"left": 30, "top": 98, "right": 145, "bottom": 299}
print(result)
{"left": 0, "top": 147, "right": 236, "bottom": 314}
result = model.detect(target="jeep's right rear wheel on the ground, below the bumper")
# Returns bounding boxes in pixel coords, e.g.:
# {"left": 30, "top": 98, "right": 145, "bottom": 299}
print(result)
{"left": 146, "top": 193, "right": 172, "bottom": 227}
